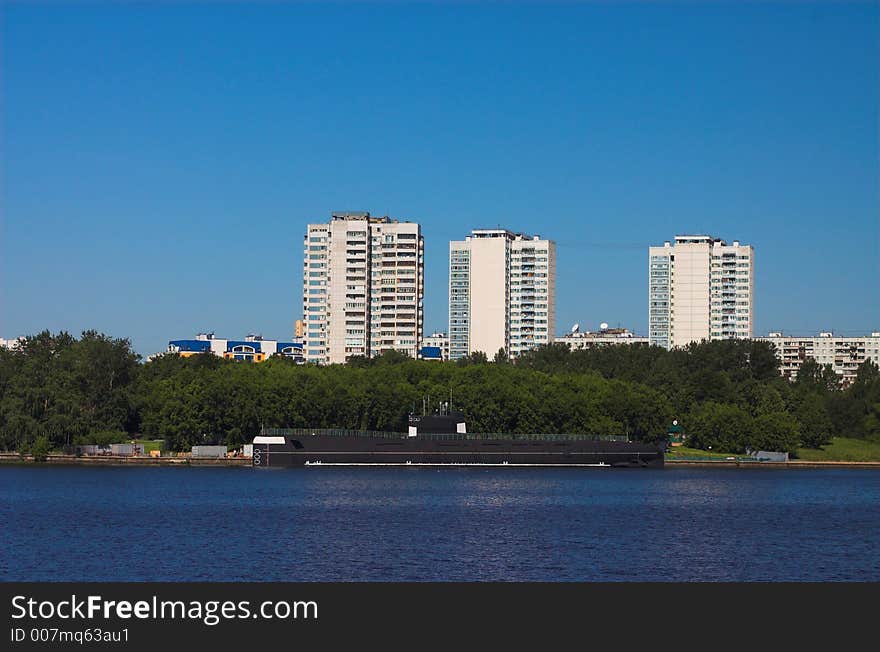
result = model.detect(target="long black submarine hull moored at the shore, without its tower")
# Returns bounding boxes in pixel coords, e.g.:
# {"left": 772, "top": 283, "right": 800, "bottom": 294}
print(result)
{"left": 253, "top": 435, "right": 663, "bottom": 468}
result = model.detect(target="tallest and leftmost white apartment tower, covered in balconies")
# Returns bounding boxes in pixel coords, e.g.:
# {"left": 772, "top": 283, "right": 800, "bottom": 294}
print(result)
{"left": 303, "top": 213, "right": 425, "bottom": 364}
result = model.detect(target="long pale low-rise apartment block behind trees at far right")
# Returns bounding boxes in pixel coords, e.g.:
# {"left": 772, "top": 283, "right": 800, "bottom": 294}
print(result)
{"left": 756, "top": 331, "right": 880, "bottom": 385}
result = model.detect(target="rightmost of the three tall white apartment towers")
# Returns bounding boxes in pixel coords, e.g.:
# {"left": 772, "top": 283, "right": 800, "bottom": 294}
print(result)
{"left": 648, "top": 235, "right": 755, "bottom": 349}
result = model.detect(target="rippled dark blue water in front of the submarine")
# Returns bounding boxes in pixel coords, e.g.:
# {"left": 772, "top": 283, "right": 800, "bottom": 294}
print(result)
{"left": 0, "top": 466, "right": 880, "bottom": 581}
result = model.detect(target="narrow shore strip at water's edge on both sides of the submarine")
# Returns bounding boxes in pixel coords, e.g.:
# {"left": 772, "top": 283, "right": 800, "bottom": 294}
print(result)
{"left": 0, "top": 453, "right": 880, "bottom": 470}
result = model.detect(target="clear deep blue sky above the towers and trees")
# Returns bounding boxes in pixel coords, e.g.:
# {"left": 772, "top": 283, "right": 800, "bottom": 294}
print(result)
{"left": 0, "top": 2, "right": 880, "bottom": 354}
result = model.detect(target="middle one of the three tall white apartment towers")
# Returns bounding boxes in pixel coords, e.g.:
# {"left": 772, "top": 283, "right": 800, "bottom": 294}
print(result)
{"left": 449, "top": 229, "right": 556, "bottom": 360}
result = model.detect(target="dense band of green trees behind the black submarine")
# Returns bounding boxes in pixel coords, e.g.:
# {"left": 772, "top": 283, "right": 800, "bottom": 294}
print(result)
{"left": 0, "top": 331, "right": 880, "bottom": 452}
